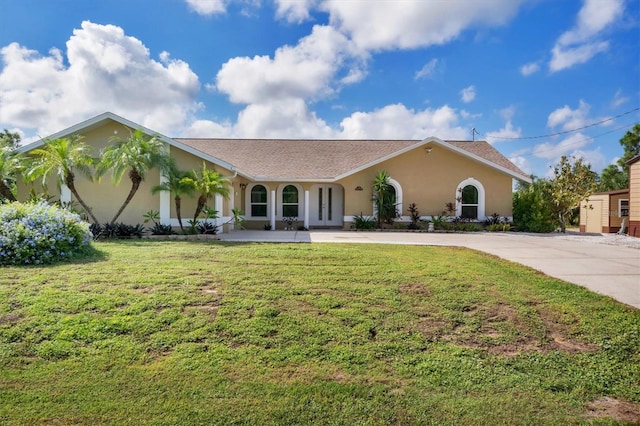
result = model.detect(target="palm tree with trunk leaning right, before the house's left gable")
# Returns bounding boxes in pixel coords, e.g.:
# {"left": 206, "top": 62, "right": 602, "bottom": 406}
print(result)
{"left": 98, "top": 129, "right": 170, "bottom": 223}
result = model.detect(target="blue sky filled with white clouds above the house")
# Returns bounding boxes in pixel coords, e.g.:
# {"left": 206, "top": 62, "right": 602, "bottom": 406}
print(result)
{"left": 0, "top": 0, "right": 640, "bottom": 176}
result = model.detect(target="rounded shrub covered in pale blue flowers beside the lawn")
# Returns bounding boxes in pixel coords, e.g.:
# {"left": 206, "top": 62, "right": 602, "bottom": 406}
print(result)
{"left": 0, "top": 202, "right": 92, "bottom": 266}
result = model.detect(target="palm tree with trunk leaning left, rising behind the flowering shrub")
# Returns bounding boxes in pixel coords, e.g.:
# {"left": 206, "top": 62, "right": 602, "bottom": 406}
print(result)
{"left": 26, "top": 135, "right": 98, "bottom": 223}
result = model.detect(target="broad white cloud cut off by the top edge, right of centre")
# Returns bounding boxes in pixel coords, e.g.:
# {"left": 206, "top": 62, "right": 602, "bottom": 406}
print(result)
{"left": 321, "top": 0, "right": 521, "bottom": 50}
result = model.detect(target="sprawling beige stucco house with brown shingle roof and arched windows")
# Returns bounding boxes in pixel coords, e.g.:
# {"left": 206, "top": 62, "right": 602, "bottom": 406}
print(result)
{"left": 18, "top": 112, "right": 531, "bottom": 231}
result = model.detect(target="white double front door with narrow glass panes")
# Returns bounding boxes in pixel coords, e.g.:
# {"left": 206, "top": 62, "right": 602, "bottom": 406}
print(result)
{"left": 309, "top": 184, "right": 344, "bottom": 227}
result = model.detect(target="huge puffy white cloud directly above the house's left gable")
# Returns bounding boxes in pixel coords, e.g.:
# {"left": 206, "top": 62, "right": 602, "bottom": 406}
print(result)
{"left": 0, "top": 21, "right": 200, "bottom": 135}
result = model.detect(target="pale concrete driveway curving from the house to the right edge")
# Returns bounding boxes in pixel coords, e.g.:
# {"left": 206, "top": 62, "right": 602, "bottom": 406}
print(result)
{"left": 220, "top": 231, "right": 640, "bottom": 309}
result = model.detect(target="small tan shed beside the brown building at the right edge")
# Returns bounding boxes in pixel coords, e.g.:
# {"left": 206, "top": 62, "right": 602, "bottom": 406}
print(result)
{"left": 580, "top": 189, "right": 629, "bottom": 234}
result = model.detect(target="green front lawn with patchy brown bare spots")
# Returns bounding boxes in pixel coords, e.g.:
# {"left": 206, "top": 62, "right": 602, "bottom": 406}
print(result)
{"left": 0, "top": 240, "right": 640, "bottom": 425}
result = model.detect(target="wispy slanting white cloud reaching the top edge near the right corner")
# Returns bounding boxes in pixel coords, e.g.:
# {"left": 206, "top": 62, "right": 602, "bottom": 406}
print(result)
{"left": 549, "top": 0, "right": 624, "bottom": 72}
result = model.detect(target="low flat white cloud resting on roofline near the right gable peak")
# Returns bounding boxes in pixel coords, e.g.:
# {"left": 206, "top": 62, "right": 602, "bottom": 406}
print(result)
{"left": 340, "top": 104, "right": 467, "bottom": 140}
